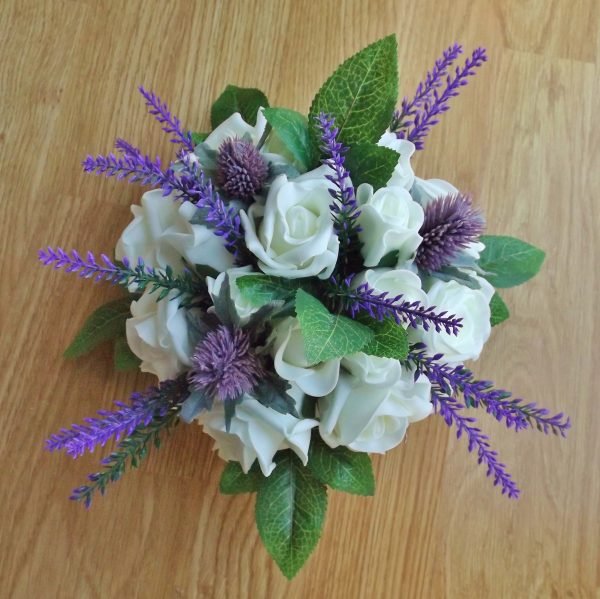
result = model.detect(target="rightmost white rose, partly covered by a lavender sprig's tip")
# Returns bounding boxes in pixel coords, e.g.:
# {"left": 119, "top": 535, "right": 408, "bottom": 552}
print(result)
{"left": 413, "top": 275, "right": 494, "bottom": 363}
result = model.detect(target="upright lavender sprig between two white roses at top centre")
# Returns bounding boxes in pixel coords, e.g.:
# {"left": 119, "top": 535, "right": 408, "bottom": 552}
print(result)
{"left": 315, "top": 113, "right": 362, "bottom": 274}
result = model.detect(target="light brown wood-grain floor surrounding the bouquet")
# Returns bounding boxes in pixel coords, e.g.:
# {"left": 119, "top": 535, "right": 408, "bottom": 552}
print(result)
{"left": 0, "top": 0, "right": 600, "bottom": 599}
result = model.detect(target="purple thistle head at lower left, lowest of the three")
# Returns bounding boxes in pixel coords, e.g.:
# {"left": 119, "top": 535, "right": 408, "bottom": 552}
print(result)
{"left": 189, "top": 325, "right": 264, "bottom": 401}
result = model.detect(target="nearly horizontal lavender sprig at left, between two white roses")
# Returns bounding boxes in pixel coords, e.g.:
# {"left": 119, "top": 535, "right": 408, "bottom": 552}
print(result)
{"left": 39, "top": 247, "right": 199, "bottom": 301}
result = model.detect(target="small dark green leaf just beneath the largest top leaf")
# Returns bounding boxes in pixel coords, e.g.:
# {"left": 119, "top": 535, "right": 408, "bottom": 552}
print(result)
{"left": 345, "top": 143, "right": 400, "bottom": 191}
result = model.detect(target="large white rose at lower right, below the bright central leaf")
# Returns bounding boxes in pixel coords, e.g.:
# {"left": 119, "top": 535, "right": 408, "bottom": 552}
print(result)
{"left": 318, "top": 369, "right": 432, "bottom": 453}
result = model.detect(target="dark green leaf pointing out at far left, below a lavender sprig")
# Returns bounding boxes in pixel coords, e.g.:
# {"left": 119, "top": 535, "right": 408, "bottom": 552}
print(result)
{"left": 63, "top": 297, "right": 131, "bottom": 358}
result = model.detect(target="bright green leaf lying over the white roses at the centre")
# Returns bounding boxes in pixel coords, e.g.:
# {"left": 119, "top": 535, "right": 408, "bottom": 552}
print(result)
{"left": 296, "top": 289, "right": 374, "bottom": 364}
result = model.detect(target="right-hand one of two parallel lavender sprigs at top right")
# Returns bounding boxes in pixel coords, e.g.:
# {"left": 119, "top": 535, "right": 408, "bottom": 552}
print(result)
{"left": 396, "top": 48, "right": 487, "bottom": 150}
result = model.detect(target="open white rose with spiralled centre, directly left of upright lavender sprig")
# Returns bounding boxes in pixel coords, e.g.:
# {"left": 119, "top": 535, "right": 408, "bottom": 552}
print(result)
{"left": 240, "top": 175, "right": 339, "bottom": 279}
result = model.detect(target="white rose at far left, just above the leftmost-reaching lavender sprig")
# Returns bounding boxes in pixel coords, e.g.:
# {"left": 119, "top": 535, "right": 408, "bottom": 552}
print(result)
{"left": 115, "top": 189, "right": 233, "bottom": 273}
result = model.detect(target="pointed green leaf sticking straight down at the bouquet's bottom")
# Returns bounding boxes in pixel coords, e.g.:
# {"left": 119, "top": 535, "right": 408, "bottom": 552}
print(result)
{"left": 255, "top": 450, "right": 327, "bottom": 579}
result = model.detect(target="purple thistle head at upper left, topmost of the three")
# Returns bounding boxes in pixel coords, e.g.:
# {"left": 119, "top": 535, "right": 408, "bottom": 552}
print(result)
{"left": 217, "top": 137, "right": 269, "bottom": 200}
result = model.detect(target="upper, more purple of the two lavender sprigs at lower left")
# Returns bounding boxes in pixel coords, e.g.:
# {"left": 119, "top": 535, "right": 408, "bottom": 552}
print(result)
{"left": 46, "top": 377, "right": 188, "bottom": 458}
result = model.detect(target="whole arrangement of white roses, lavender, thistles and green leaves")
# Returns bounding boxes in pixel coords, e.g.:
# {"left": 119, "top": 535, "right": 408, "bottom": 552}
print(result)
{"left": 39, "top": 36, "right": 570, "bottom": 578}
